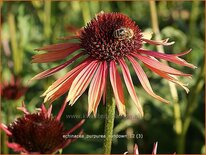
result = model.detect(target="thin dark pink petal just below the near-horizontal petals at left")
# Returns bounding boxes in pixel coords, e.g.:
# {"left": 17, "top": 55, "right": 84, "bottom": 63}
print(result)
{"left": 30, "top": 53, "right": 83, "bottom": 81}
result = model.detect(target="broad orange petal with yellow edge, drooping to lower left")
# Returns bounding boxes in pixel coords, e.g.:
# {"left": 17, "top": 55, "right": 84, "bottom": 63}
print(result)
{"left": 42, "top": 59, "right": 91, "bottom": 102}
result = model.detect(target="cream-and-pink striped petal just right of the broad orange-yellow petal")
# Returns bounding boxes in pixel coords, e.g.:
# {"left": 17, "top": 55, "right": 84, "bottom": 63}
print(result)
{"left": 66, "top": 60, "right": 98, "bottom": 105}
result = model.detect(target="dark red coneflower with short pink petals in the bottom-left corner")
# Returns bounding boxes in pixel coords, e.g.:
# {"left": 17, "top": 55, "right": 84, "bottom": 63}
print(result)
{"left": 0, "top": 101, "right": 84, "bottom": 154}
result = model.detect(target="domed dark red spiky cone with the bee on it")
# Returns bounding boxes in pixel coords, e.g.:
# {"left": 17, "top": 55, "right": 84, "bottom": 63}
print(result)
{"left": 80, "top": 13, "right": 142, "bottom": 61}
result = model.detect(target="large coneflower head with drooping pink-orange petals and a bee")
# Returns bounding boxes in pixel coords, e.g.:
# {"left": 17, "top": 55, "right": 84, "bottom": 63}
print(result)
{"left": 32, "top": 12, "right": 195, "bottom": 116}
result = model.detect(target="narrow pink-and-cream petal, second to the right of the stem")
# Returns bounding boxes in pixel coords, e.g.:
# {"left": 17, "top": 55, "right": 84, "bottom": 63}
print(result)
{"left": 119, "top": 59, "right": 144, "bottom": 116}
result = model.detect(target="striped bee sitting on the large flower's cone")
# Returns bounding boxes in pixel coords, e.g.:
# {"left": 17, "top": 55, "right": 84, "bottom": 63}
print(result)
{"left": 113, "top": 27, "right": 134, "bottom": 40}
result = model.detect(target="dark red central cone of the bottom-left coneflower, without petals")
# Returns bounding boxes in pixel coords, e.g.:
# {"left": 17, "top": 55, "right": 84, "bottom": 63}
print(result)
{"left": 8, "top": 113, "right": 65, "bottom": 153}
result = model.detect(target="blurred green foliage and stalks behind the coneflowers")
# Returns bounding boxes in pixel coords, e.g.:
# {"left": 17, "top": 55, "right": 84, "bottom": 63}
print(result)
{"left": 0, "top": 0, "right": 206, "bottom": 154}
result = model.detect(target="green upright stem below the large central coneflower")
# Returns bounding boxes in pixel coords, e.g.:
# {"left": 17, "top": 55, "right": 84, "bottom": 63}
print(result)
{"left": 104, "top": 80, "right": 115, "bottom": 154}
